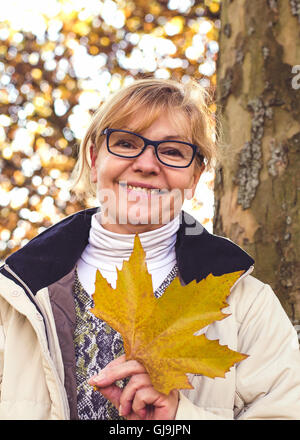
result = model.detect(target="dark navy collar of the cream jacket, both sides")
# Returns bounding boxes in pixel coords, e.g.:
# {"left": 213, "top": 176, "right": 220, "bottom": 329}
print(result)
{"left": 1, "top": 208, "right": 254, "bottom": 294}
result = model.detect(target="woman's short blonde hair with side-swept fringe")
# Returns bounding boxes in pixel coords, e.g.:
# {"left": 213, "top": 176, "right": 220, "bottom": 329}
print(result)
{"left": 70, "top": 78, "right": 218, "bottom": 200}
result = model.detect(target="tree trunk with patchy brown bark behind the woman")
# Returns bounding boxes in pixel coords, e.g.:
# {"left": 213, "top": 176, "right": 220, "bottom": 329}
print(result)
{"left": 214, "top": 0, "right": 300, "bottom": 329}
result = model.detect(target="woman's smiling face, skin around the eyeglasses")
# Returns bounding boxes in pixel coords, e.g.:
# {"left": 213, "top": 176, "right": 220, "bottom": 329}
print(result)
{"left": 90, "top": 114, "right": 201, "bottom": 234}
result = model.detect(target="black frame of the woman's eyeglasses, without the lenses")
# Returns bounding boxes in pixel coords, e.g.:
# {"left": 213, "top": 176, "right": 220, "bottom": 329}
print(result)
{"left": 101, "top": 128, "right": 204, "bottom": 168}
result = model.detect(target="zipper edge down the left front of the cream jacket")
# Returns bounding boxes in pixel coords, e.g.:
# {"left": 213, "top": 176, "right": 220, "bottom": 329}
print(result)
{"left": 4, "top": 264, "right": 70, "bottom": 419}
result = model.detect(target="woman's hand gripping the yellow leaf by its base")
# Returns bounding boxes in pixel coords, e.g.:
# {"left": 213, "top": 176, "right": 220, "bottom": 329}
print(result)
{"left": 88, "top": 355, "right": 179, "bottom": 420}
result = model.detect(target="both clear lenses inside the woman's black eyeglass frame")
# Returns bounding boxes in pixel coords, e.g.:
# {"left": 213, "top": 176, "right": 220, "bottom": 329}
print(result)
{"left": 108, "top": 131, "right": 193, "bottom": 166}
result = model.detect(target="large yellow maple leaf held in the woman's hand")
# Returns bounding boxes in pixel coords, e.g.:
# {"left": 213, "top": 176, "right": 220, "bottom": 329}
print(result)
{"left": 91, "top": 236, "right": 247, "bottom": 394}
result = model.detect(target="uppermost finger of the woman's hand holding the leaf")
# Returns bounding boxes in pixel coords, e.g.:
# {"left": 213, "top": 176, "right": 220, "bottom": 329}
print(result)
{"left": 91, "top": 360, "right": 146, "bottom": 387}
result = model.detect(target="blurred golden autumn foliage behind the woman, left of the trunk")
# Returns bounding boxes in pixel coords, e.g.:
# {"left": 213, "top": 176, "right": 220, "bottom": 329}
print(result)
{"left": 0, "top": 0, "right": 220, "bottom": 259}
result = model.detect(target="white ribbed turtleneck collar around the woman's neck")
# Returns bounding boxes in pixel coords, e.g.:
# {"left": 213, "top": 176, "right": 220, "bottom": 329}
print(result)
{"left": 77, "top": 212, "right": 180, "bottom": 295}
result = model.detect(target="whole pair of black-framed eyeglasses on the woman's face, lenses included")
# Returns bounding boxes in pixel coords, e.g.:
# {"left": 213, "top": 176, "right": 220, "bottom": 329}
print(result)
{"left": 101, "top": 128, "right": 204, "bottom": 168}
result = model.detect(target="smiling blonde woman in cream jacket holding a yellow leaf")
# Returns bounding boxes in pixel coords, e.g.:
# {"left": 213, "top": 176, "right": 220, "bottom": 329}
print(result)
{"left": 0, "top": 79, "right": 300, "bottom": 420}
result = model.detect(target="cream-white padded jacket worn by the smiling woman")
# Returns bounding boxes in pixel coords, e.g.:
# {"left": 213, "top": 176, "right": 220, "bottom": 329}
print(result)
{"left": 0, "top": 210, "right": 300, "bottom": 420}
